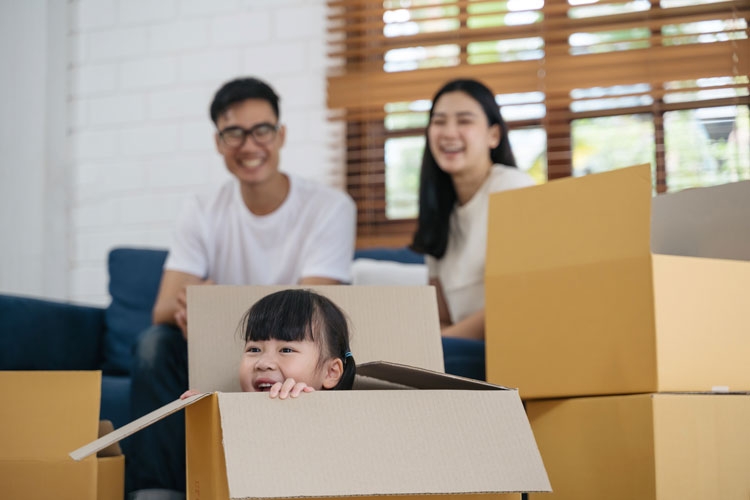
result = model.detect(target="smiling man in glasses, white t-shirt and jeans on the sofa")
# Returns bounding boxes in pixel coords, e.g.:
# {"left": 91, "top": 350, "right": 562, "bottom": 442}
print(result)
{"left": 126, "top": 78, "right": 356, "bottom": 500}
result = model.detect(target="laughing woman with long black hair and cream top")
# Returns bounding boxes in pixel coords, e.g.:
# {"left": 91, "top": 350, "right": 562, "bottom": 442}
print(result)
{"left": 411, "top": 79, "right": 534, "bottom": 371}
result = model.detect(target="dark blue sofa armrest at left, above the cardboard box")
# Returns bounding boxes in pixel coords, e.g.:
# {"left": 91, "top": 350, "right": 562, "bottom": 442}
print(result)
{"left": 0, "top": 295, "right": 105, "bottom": 370}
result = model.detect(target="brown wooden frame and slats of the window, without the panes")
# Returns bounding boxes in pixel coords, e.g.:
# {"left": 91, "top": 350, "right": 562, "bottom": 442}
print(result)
{"left": 328, "top": 0, "right": 750, "bottom": 247}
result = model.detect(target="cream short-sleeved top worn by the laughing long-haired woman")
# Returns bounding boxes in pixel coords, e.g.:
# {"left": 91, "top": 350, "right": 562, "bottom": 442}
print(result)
{"left": 425, "top": 165, "right": 535, "bottom": 323}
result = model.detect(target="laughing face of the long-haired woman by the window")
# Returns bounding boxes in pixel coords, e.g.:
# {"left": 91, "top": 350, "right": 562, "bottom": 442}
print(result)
{"left": 427, "top": 91, "right": 500, "bottom": 175}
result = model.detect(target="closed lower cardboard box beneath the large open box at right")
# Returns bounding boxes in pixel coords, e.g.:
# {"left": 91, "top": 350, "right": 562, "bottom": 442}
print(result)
{"left": 526, "top": 393, "right": 750, "bottom": 500}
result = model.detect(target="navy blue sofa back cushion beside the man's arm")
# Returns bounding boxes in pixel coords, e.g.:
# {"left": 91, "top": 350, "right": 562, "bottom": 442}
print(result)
{"left": 102, "top": 248, "right": 167, "bottom": 374}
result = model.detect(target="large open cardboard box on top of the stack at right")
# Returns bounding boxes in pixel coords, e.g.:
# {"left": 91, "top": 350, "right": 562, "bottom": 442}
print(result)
{"left": 485, "top": 165, "right": 750, "bottom": 400}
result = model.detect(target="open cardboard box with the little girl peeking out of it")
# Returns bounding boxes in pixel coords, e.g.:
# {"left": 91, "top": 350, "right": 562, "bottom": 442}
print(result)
{"left": 71, "top": 286, "right": 549, "bottom": 500}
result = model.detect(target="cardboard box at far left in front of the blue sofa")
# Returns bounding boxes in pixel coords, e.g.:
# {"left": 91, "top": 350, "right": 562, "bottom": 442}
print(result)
{"left": 0, "top": 371, "right": 125, "bottom": 500}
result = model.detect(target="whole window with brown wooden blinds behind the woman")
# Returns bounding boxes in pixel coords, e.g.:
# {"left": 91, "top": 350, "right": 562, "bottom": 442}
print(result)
{"left": 328, "top": 0, "right": 750, "bottom": 246}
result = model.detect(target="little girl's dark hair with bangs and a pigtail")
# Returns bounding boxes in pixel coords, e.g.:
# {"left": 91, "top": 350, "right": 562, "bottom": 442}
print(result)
{"left": 242, "top": 289, "right": 357, "bottom": 391}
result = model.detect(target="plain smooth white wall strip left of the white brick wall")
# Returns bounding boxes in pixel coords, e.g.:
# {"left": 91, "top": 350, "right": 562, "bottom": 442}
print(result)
{"left": 0, "top": 0, "right": 70, "bottom": 298}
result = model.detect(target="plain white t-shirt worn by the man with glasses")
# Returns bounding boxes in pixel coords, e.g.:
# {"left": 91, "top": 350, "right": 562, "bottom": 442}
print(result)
{"left": 164, "top": 174, "right": 356, "bottom": 285}
